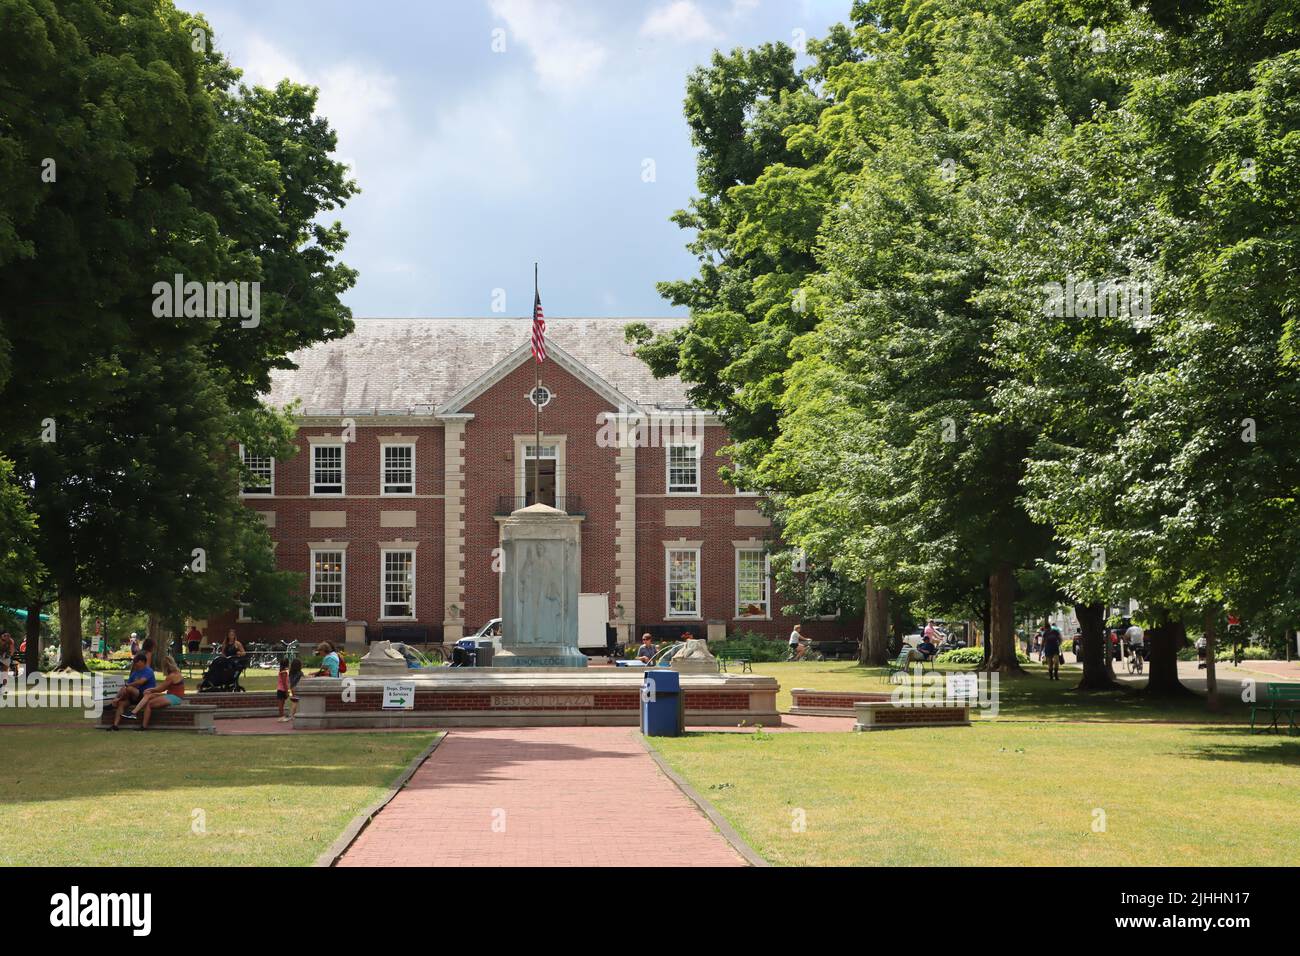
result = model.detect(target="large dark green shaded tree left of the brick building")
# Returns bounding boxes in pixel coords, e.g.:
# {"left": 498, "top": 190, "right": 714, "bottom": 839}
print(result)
{"left": 0, "top": 0, "right": 355, "bottom": 667}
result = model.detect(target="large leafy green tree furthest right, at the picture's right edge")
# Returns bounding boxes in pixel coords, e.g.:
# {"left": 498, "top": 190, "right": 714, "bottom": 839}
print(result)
{"left": 984, "top": 3, "right": 1300, "bottom": 695}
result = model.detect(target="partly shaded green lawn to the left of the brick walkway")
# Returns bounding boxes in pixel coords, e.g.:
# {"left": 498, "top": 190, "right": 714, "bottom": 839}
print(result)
{"left": 0, "top": 710, "right": 437, "bottom": 866}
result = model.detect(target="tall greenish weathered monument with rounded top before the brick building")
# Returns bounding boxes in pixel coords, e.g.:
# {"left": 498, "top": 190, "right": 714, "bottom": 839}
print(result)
{"left": 493, "top": 505, "right": 586, "bottom": 667}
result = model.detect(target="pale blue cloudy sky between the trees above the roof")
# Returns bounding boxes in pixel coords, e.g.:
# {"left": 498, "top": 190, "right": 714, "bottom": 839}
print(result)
{"left": 189, "top": 0, "right": 849, "bottom": 317}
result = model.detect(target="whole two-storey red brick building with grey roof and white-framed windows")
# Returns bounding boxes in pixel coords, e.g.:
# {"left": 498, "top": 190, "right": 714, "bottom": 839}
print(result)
{"left": 218, "top": 319, "right": 859, "bottom": 643}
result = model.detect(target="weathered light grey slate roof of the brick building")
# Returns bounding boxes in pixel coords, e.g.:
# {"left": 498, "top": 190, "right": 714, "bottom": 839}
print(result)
{"left": 268, "top": 317, "right": 689, "bottom": 415}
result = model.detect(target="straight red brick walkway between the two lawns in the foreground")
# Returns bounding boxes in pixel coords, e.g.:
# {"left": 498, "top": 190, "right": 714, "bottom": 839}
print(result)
{"left": 330, "top": 727, "right": 744, "bottom": 866}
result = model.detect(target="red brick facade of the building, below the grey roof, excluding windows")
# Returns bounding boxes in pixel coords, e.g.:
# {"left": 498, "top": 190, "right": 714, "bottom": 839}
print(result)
{"left": 218, "top": 330, "right": 861, "bottom": 643}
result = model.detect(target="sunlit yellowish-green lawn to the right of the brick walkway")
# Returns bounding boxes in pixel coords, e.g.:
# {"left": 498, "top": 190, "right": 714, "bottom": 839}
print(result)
{"left": 654, "top": 721, "right": 1300, "bottom": 866}
